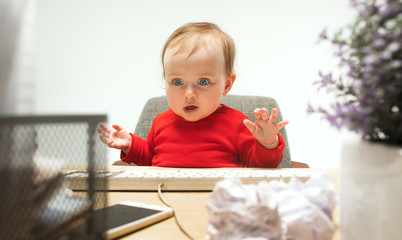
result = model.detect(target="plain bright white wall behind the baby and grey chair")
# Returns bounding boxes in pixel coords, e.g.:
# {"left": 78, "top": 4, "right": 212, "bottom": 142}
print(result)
{"left": 35, "top": 0, "right": 354, "bottom": 167}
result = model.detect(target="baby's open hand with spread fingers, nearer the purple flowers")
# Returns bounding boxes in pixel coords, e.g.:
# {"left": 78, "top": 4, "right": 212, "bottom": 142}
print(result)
{"left": 243, "top": 108, "right": 289, "bottom": 149}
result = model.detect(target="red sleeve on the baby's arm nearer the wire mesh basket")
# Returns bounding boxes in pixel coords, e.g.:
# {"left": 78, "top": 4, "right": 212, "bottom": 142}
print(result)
{"left": 120, "top": 133, "right": 153, "bottom": 166}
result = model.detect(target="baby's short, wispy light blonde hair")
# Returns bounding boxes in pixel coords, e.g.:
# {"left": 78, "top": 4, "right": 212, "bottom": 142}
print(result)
{"left": 162, "top": 22, "right": 235, "bottom": 76}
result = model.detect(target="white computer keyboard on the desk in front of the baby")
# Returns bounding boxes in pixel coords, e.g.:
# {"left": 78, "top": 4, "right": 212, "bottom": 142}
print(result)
{"left": 63, "top": 167, "right": 313, "bottom": 191}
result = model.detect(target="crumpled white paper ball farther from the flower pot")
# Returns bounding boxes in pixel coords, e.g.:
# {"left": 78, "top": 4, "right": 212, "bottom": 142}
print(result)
{"left": 206, "top": 178, "right": 282, "bottom": 240}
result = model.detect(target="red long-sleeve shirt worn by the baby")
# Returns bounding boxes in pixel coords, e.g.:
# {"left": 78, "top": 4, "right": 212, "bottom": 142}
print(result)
{"left": 121, "top": 104, "right": 285, "bottom": 168}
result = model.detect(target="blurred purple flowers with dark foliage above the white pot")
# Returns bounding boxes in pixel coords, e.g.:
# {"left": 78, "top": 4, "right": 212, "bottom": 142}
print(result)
{"left": 307, "top": 0, "right": 402, "bottom": 145}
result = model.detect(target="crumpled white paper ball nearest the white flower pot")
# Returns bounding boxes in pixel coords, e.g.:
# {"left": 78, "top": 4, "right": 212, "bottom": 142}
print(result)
{"left": 270, "top": 172, "right": 338, "bottom": 240}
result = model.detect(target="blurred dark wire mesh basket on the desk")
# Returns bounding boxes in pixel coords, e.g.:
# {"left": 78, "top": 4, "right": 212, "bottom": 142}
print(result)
{"left": 0, "top": 115, "right": 107, "bottom": 240}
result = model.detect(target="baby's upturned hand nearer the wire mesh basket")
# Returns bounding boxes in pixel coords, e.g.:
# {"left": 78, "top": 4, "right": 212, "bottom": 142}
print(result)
{"left": 97, "top": 123, "right": 131, "bottom": 153}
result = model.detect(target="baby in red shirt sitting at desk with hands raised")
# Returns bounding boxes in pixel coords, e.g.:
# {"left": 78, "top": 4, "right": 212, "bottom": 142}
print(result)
{"left": 98, "top": 22, "right": 288, "bottom": 168}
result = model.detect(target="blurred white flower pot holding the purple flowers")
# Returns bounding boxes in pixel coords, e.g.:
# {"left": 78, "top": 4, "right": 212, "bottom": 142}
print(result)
{"left": 340, "top": 139, "right": 402, "bottom": 240}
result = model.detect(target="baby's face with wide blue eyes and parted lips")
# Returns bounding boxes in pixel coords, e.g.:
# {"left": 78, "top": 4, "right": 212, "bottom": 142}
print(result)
{"left": 164, "top": 45, "right": 236, "bottom": 122}
